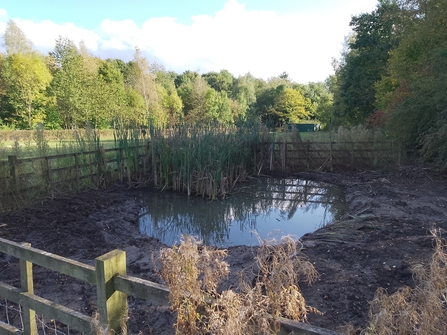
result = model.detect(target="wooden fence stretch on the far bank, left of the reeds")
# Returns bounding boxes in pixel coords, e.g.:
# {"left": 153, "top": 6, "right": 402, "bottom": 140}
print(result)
{"left": 0, "top": 146, "right": 148, "bottom": 212}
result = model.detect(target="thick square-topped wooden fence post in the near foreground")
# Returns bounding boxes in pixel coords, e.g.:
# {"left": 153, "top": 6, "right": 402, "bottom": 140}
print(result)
{"left": 95, "top": 250, "right": 127, "bottom": 334}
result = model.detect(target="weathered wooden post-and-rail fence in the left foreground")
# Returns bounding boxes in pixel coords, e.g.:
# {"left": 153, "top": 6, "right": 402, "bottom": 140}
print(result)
{"left": 0, "top": 238, "right": 169, "bottom": 335}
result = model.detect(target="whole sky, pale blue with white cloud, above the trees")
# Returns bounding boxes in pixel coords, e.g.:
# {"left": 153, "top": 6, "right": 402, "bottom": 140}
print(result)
{"left": 0, "top": 0, "right": 378, "bottom": 84}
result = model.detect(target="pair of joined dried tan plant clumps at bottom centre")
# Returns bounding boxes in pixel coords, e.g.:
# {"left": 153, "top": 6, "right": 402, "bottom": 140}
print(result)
{"left": 156, "top": 236, "right": 319, "bottom": 335}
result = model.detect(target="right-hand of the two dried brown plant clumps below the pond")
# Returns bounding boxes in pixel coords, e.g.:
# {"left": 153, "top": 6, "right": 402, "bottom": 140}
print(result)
{"left": 245, "top": 235, "right": 320, "bottom": 334}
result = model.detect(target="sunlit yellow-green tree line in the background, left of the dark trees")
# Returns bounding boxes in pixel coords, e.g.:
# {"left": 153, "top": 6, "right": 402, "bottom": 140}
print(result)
{"left": 0, "top": 20, "right": 332, "bottom": 129}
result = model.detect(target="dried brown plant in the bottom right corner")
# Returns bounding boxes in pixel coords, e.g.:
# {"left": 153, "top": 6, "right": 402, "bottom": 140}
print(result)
{"left": 362, "top": 228, "right": 447, "bottom": 335}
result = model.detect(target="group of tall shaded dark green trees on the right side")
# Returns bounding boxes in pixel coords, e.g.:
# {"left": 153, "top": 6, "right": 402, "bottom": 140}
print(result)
{"left": 329, "top": 0, "right": 447, "bottom": 166}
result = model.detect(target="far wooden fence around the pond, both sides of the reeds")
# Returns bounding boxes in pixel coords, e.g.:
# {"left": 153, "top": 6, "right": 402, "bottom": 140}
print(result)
{"left": 0, "top": 142, "right": 405, "bottom": 212}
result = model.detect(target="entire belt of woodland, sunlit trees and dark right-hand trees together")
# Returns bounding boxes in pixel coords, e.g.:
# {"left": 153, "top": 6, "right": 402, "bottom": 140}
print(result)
{"left": 0, "top": 0, "right": 447, "bottom": 166}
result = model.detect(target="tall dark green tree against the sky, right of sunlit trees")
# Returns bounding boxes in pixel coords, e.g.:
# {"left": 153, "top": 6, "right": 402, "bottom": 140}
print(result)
{"left": 334, "top": 0, "right": 400, "bottom": 124}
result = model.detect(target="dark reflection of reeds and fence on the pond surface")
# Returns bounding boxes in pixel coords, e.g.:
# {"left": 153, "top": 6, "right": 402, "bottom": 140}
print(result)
{"left": 140, "top": 178, "right": 346, "bottom": 245}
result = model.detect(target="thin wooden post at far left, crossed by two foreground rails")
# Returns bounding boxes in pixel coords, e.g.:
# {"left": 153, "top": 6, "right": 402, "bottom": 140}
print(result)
{"left": 20, "top": 243, "right": 37, "bottom": 335}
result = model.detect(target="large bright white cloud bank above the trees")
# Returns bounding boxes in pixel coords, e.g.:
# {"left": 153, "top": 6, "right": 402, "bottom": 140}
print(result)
{"left": 0, "top": 0, "right": 376, "bottom": 82}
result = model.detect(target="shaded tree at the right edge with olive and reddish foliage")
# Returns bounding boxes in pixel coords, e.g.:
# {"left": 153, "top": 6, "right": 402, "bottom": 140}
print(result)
{"left": 377, "top": 0, "right": 447, "bottom": 167}
